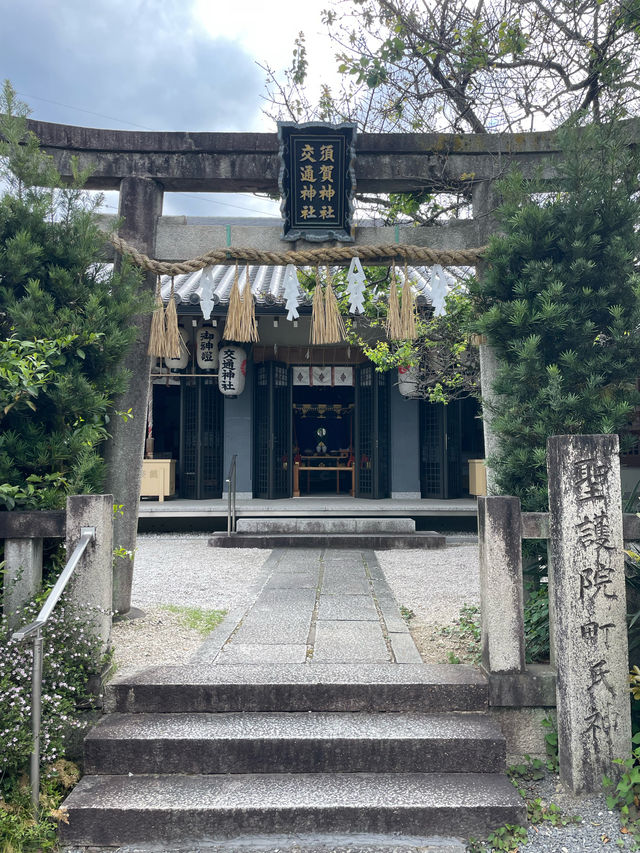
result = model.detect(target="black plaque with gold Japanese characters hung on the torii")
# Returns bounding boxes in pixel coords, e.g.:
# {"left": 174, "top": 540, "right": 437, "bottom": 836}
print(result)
{"left": 278, "top": 122, "right": 356, "bottom": 243}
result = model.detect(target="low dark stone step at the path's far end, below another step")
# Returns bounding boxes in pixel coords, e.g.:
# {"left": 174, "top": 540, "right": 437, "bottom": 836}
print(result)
{"left": 209, "top": 530, "right": 446, "bottom": 551}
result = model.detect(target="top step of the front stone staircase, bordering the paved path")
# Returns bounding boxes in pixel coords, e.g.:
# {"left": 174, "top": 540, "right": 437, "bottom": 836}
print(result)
{"left": 105, "top": 663, "right": 488, "bottom": 713}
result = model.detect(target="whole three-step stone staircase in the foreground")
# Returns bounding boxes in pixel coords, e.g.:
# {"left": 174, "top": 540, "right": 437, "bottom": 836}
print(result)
{"left": 62, "top": 664, "right": 525, "bottom": 851}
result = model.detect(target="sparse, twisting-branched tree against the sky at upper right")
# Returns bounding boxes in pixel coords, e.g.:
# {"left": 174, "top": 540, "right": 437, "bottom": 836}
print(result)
{"left": 265, "top": 0, "right": 640, "bottom": 224}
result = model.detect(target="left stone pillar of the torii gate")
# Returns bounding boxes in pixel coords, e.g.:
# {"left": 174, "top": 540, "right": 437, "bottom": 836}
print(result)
{"left": 105, "top": 178, "right": 163, "bottom": 613}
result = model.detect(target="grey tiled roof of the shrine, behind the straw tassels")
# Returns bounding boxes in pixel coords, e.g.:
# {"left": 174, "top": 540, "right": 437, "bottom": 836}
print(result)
{"left": 162, "top": 266, "right": 438, "bottom": 310}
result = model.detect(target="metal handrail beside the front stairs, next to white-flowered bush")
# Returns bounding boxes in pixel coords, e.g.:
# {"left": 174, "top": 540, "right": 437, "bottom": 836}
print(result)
{"left": 12, "top": 527, "right": 96, "bottom": 812}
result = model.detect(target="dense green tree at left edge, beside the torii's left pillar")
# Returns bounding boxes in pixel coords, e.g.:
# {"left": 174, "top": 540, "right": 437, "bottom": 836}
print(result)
{"left": 0, "top": 82, "right": 139, "bottom": 507}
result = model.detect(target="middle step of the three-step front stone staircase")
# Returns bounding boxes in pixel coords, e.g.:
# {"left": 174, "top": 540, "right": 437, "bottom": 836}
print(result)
{"left": 84, "top": 713, "right": 506, "bottom": 775}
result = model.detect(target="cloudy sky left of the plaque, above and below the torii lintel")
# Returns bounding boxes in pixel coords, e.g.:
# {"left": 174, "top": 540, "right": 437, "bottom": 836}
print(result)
{"left": 0, "top": 0, "right": 334, "bottom": 216}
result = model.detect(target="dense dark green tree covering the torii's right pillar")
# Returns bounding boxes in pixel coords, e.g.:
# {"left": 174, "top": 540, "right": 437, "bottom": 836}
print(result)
{"left": 472, "top": 125, "right": 640, "bottom": 511}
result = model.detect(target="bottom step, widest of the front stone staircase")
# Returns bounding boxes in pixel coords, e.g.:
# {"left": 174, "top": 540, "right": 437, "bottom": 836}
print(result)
{"left": 61, "top": 773, "right": 525, "bottom": 849}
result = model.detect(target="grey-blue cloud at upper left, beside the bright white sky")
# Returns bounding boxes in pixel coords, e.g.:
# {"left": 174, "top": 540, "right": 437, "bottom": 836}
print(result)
{"left": 0, "top": 0, "right": 262, "bottom": 130}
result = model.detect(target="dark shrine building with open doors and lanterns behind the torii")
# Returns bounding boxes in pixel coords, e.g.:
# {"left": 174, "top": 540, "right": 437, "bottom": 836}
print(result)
{"left": 146, "top": 266, "right": 484, "bottom": 500}
